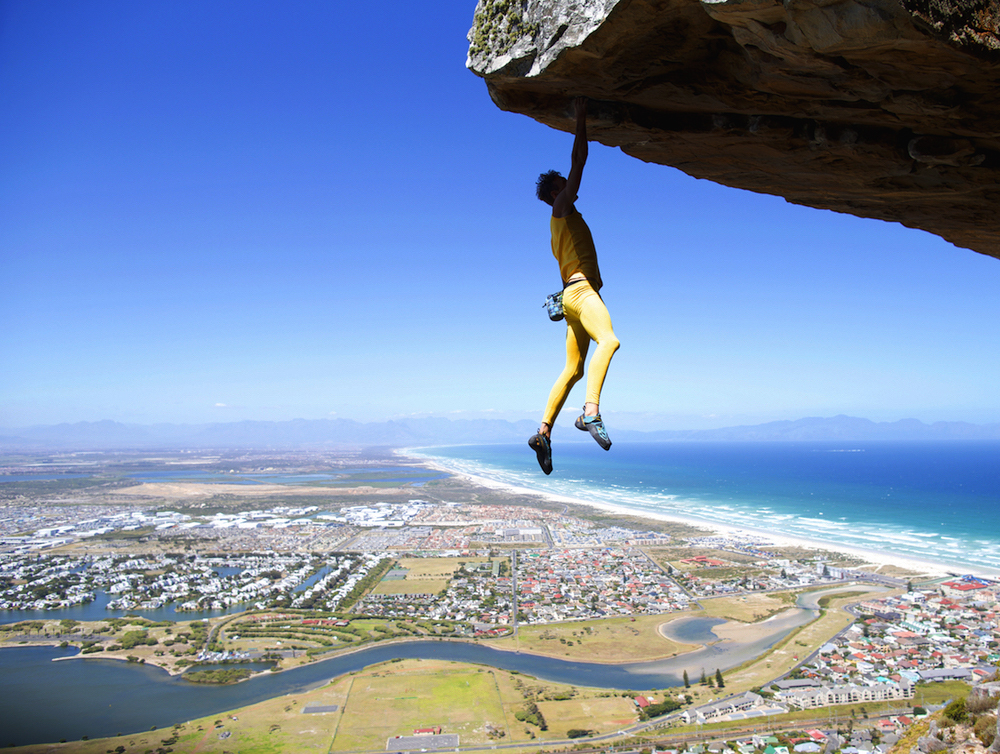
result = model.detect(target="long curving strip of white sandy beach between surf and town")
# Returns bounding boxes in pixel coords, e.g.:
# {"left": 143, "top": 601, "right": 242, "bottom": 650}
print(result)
{"left": 396, "top": 447, "right": 1000, "bottom": 579}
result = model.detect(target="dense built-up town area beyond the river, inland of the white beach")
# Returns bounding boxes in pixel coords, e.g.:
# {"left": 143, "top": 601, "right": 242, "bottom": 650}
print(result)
{"left": 0, "top": 499, "right": 902, "bottom": 624}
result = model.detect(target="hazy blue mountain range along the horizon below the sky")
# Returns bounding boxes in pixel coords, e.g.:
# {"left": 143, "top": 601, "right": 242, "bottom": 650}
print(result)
{"left": 0, "top": 416, "right": 1000, "bottom": 450}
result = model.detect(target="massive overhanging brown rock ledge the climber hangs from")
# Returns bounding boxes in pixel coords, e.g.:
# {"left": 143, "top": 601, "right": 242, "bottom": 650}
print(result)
{"left": 467, "top": 0, "right": 1000, "bottom": 258}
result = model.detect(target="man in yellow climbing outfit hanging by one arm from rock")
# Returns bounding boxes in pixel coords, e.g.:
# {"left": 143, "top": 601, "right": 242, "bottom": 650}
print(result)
{"left": 528, "top": 92, "right": 619, "bottom": 474}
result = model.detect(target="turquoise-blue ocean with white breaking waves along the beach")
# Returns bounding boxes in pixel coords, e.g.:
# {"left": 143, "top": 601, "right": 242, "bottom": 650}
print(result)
{"left": 407, "top": 437, "right": 1000, "bottom": 574}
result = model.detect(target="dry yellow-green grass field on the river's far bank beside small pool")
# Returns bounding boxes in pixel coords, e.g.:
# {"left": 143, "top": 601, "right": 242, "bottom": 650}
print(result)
{"left": 490, "top": 613, "right": 696, "bottom": 662}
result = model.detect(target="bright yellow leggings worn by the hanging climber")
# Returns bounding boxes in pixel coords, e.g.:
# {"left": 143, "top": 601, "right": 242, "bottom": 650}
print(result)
{"left": 542, "top": 281, "right": 619, "bottom": 427}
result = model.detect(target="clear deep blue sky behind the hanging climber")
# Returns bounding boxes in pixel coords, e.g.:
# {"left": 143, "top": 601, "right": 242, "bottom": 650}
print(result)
{"left": 0, "top": 0, "right": 1000, "bottom": 428}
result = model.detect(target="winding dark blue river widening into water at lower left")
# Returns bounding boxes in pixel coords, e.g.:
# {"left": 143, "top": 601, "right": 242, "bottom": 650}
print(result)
{"left": 0, "top": 587, "right": 870, "bottom": 746}
